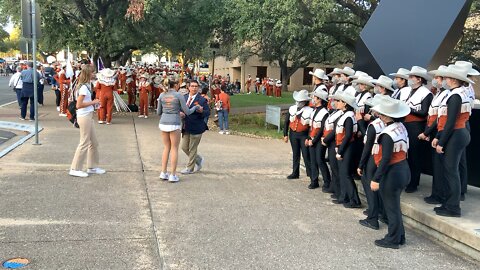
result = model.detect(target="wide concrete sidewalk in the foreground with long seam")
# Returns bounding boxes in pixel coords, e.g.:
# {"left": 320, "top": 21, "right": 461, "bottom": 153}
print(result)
{"left": 0, "top": 93, "right": 479, "bottom": 269}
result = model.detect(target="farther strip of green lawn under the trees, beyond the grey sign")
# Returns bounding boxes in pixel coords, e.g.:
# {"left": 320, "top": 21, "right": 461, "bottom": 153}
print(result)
{"left": 230, "top": 92, "right": 294, "bottom": 108}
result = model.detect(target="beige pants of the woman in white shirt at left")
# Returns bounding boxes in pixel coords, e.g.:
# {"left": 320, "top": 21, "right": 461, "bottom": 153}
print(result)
{"left": 71, "top": 112, "right": 99, "bottom": 171}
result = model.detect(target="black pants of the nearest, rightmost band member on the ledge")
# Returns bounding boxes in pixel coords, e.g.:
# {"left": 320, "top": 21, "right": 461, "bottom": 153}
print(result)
{"left": 442, "top": 128, "right": 470, "bottom": 213}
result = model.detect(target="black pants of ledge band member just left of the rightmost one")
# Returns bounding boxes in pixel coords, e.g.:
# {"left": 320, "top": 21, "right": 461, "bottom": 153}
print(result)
{"left": 404, "top": 122, "right": 428, "bottom": 188}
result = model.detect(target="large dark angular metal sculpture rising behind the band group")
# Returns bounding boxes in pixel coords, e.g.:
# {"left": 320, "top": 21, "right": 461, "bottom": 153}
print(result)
{"left": 354, "top": 0, "right": 472, "bottom": 77}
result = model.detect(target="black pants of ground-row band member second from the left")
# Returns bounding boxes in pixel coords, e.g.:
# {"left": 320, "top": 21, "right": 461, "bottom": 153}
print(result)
{"left": 308, "top": 142, "right": 331, "bottom": 188}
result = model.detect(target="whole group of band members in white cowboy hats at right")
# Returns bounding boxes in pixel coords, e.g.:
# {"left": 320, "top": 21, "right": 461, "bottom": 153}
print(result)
{"left": 284, "top": 61, "right": 480, "bottom": 249}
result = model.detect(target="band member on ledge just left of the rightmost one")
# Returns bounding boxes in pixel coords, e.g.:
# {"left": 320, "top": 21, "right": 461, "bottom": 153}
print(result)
{"left": 404, "top": 66, "right": 433, "bottom": 193}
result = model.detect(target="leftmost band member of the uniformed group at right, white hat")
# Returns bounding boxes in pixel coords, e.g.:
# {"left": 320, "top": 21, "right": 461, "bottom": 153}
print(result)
{"left": 283, "top": 90, "right": 313, "bottom": 179}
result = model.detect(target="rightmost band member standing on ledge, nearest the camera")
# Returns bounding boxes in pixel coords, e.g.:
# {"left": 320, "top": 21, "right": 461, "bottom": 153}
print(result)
{"left": 432, "top": 65, "right": 473, "bottom": 217}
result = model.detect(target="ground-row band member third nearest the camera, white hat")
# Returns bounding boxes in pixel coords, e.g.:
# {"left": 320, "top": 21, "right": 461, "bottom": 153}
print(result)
{"left": 333, "top": 92, "right": 361, "bottom": 208}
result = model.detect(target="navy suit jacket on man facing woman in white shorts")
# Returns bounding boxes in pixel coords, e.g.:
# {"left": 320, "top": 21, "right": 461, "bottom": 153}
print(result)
{"left": 183, "top": 93, "right": 210, "bottom": 135}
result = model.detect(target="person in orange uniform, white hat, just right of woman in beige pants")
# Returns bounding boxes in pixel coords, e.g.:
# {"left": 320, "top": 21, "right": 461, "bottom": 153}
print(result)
{"left": 95, "top": 68, "right": 118, "bottom": 125}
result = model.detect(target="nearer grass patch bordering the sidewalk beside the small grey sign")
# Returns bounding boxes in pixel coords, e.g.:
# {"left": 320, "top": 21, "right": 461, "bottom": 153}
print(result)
{"left": 228, "top": 113, "right": 283, "bottom": 139}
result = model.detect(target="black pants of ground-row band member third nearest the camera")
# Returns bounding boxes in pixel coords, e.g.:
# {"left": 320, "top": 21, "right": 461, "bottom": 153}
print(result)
{"left": 338, "top": 145, "right": 361, "bottom": 205}
